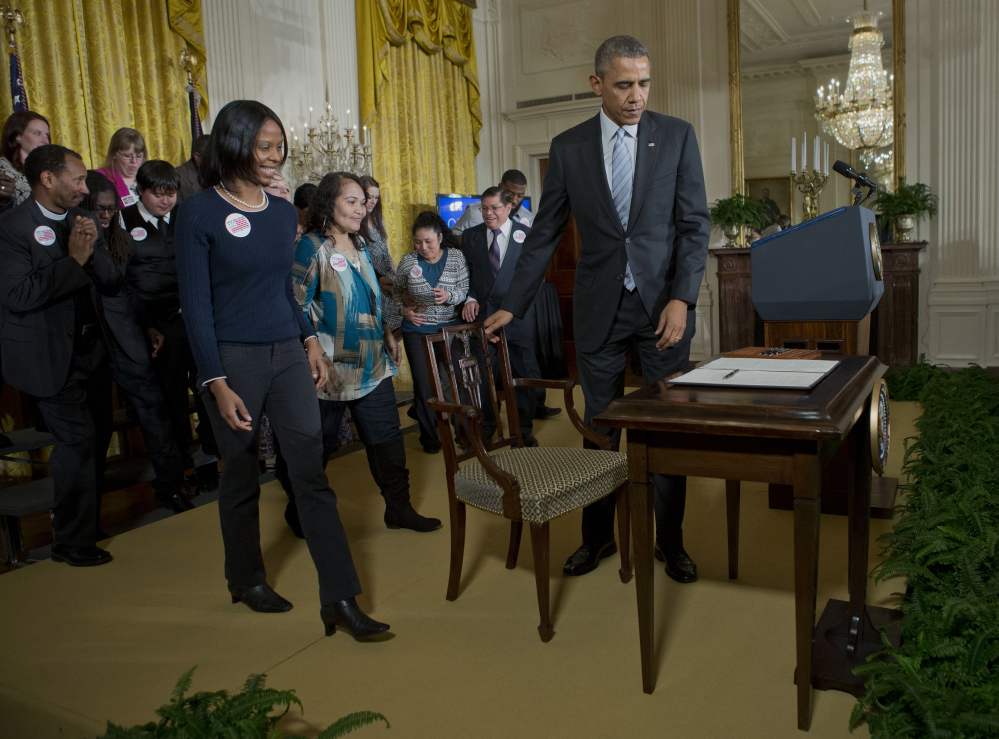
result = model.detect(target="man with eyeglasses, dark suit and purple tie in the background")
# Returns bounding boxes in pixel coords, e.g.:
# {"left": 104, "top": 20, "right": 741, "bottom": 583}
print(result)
{"left": 461, "top": 187, "right": 540, "bottom": 447}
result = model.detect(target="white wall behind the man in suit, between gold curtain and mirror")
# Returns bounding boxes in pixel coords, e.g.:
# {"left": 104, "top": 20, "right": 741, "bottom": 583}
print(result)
{"left": 473, "top": 0, "right": 731, "bottom": 359}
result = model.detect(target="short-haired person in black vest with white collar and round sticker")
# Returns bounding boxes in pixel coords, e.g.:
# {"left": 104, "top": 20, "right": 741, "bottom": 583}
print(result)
{"left": 121, "top": 159, "right": 217, "bottom": 466}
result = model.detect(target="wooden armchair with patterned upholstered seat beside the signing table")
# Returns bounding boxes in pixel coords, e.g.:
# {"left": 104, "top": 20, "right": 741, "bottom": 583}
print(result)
{"left": 423, "top": 323, "right": 631, "bottom": 642}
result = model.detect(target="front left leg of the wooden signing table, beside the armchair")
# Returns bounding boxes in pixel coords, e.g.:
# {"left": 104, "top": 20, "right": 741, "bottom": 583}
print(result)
{"left": 628, "top": 429, "right": 655, "bottom": 693}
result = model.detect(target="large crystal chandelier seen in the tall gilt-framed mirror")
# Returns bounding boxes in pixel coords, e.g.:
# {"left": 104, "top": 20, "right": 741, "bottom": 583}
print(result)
{"left": 815, "top": 0, "right": 894, "bottom": 167}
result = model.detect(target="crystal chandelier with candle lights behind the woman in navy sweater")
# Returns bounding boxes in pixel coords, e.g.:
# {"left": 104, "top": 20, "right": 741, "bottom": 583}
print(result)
{"left": 288, "top": 103, "right": 372, "bottom": 182}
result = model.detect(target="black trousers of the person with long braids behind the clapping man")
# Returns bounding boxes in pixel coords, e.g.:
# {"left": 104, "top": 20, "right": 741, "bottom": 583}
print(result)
{"left": 102, "top": 343, "right": 186, "bottom": 497}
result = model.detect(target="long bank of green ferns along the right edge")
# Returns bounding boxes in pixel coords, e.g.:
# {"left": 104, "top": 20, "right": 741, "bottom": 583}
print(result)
{"left": 851, "top": 362, "right": 999, "bottom": 739}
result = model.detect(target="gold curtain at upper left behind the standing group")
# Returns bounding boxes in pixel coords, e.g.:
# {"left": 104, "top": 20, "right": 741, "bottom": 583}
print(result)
{"left": 0, "top": 0, "right": 208, "bottom": 167}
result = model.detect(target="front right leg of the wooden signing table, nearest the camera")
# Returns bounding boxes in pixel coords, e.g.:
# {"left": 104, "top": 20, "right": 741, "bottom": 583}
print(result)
{"left": 794, "top": 454, "right": 822, "bottom": 731}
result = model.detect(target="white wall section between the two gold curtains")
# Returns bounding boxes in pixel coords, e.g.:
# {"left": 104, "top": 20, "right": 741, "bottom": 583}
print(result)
{"left": 201, "top": 0, "right": 358, "bottom": 185}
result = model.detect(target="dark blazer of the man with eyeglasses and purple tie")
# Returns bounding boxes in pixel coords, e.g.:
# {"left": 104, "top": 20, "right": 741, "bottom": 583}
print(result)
{"left": 461, "top": 221, "right": 534, "bottom": 343}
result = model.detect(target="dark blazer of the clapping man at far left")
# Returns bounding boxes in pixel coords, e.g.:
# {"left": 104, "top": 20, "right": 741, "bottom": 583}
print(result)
{"left": 0, "top": 198, "right": 125, "bottom": 398}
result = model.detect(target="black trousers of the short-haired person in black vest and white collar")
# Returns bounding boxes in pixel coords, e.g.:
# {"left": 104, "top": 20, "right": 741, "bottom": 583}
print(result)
{"left": 153, "top": 313, "right": 215, "bottom": 455}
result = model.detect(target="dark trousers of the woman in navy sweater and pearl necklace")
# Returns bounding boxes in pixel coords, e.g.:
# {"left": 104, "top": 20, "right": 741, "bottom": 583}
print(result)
{"left": 205, "top": 339, "right": 361, "bottom": 605}
